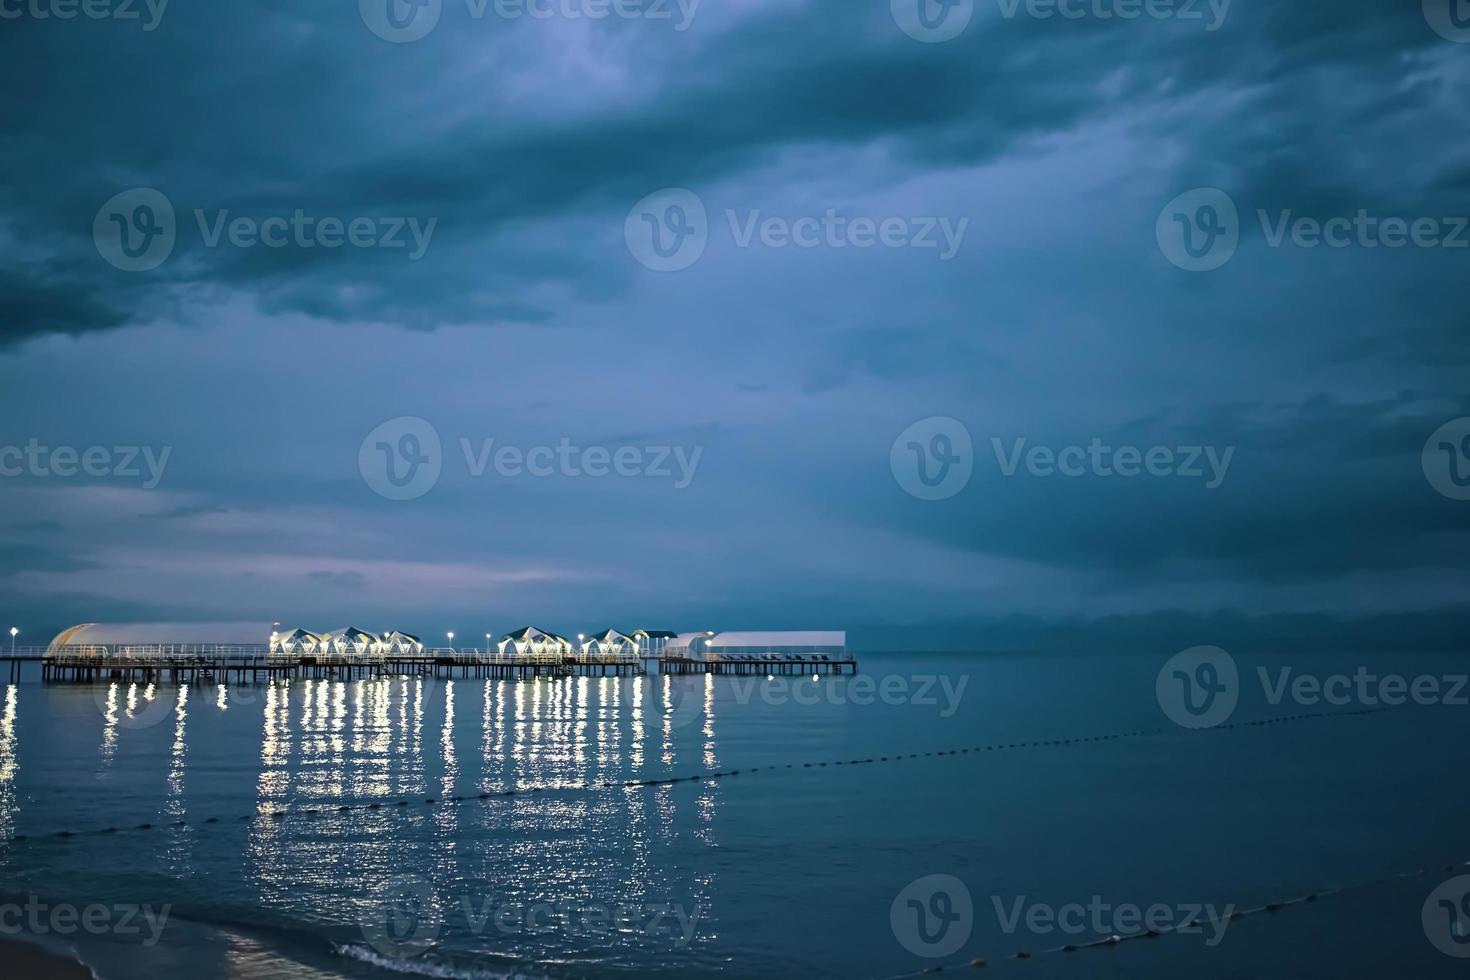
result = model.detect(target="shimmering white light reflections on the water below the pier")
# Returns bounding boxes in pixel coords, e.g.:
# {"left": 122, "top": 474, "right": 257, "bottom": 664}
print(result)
{"left": 129, "top": 677, "right": 732, "bottom": 955}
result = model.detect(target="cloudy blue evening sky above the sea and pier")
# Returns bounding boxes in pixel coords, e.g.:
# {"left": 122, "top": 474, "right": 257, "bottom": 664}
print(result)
{"left": 0, "top": 0, "right": 1470, "bottom": 649}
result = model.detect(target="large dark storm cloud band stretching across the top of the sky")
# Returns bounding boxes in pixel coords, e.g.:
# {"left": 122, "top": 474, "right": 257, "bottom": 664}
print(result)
{"left": 0, "top": 3, "right": 1463, "bottom": 341}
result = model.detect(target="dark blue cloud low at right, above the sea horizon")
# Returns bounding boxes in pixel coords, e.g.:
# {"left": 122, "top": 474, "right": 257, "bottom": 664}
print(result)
{"left": 854, "top": 392, "right": 1470, "bottom": 583}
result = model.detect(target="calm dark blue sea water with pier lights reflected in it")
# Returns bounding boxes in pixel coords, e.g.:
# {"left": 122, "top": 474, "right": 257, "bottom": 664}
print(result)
{"left": 0, "top": 654, "right": 1470, "bottom": 980}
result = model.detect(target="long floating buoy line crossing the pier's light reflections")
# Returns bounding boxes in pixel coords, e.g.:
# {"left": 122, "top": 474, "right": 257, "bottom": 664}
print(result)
{"left": 0, "top": 708, "right": 1389, "bottom": 843}
